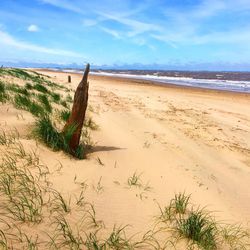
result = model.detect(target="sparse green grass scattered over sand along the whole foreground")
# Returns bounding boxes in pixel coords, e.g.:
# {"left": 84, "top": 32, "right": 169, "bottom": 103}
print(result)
{"left": 0, "top": 131, "right": 250, "bottom": 250}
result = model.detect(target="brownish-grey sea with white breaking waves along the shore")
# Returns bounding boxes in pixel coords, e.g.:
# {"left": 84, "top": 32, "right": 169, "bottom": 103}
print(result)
{"left": 51, "top": 69, "right": 250, "bottom": 93}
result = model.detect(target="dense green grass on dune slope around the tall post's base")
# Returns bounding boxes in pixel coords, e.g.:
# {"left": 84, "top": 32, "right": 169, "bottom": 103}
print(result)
{"left": 0, "top": 68, "right": 93, "bottom": 159}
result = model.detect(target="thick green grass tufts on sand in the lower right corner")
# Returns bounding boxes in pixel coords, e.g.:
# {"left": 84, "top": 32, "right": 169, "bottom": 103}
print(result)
{"left": 157, "top": 192, "right": 250, "bottom": 250}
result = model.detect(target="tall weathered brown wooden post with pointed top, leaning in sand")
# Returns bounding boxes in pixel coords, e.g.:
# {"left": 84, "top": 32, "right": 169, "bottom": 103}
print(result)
{"left": 63, "top": 64, "right": 90, "bottom": 155}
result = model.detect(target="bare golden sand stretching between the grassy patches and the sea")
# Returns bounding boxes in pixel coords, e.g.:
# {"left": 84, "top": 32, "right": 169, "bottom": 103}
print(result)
{"left": 0, "top": 70, "right": 250, "bottom": 236}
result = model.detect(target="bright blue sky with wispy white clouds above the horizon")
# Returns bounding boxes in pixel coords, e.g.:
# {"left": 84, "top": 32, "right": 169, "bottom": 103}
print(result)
{"left": 0, "top": 0, "right": 250, "bottom": 68}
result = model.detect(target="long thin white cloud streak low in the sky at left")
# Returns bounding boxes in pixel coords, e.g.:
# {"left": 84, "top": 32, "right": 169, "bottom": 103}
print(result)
{"left": 0, "top": 30, "right": 82, "bottom": 58}
